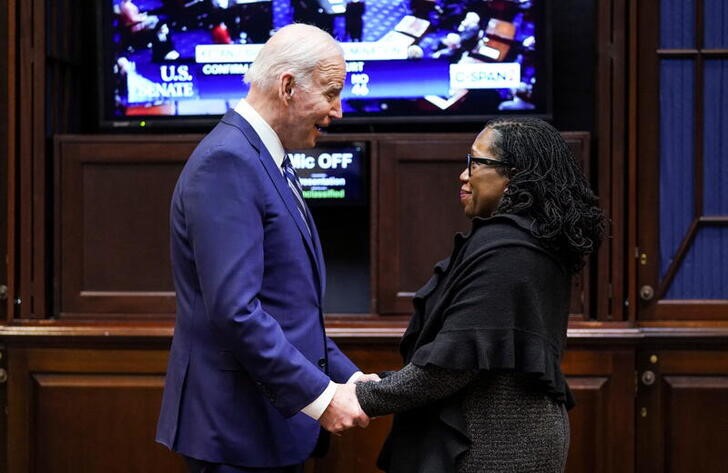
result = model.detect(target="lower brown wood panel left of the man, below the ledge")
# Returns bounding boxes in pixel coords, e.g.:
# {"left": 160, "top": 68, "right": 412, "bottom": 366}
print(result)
{"left": 8, "top": 342, "right": 184, "bottom": 473}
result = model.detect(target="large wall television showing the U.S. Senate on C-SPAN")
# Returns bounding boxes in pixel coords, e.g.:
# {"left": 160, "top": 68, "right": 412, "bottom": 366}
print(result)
{"left": 98, "top": 0, "right": 551, "bottom": 128}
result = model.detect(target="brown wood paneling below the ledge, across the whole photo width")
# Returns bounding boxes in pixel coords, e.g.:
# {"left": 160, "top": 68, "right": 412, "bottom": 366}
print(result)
{"left": 12, "top": 328, "right": 728, "bottom": 473}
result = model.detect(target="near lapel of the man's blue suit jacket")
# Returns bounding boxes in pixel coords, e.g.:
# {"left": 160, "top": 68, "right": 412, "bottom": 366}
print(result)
{"left": 222, "top": 110, "right": 325, "bottom": 298}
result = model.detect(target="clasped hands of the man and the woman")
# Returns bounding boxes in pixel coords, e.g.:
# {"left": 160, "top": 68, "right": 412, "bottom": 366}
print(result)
{"left": 319, "top": 373, "right": 381, "bottom": 434}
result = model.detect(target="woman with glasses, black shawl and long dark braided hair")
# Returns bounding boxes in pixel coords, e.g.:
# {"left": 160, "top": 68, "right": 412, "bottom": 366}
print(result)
{"left": 356, "top": 118, "right": 605, "bottom": 473}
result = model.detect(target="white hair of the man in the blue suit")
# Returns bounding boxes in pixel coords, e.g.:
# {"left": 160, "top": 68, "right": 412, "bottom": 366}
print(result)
{"left": 245, "top": 23, "right": 344, "bottom": 90}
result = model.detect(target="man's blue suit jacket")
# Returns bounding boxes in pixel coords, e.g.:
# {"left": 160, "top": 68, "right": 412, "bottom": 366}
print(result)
{"left": 157, "top": 111, "right": 356, "bottom": 467}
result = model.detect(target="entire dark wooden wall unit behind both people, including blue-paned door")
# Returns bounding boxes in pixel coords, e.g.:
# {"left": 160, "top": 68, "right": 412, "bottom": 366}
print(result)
{"left": 5, "top": 0, "right": 728, "bottom": 473}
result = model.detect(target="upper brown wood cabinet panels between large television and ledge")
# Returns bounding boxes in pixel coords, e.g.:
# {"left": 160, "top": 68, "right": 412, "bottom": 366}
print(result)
{"left": 53, "top": 132, "right": 593, "bottom": 320}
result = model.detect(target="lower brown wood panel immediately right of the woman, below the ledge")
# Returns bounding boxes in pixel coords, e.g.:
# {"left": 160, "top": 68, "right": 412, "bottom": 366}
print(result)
{"left": 562, "top": 347, "right": 634, "bottom": 473}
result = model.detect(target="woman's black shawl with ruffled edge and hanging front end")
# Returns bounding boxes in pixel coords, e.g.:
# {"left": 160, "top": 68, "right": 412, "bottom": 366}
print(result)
{"left": 378, "top": 215, "right": 573, "bottom": 473}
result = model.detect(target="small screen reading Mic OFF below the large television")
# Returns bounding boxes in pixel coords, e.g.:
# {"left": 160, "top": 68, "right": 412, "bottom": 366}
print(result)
{"left": 288, "top": 143, "right": 368, "bottom": 206}
